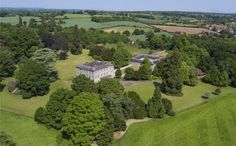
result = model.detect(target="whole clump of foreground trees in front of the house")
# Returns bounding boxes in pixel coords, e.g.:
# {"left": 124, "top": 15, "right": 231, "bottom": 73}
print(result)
{"left": 35, "top": 75, "right": 174, "bottom": 146}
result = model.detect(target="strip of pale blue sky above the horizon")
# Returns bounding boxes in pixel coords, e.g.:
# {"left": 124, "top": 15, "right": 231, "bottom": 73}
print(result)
{"left": 0, "top": 0, "right": 236, "bottom": 13}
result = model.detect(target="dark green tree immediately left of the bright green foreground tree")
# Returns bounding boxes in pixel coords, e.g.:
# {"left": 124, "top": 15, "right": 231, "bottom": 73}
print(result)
{"left": 45, "top": 88, "right": 74, "bottom": 130}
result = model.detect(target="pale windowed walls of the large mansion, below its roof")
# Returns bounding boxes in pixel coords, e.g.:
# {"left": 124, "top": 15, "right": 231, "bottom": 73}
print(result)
{"left": 77, "top": 61, "right": 115, "bottom": 83}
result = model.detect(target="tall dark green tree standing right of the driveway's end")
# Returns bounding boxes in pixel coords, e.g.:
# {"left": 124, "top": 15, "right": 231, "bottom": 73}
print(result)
{"left": 161, "top": 50, "right": 183, "bottom": 95}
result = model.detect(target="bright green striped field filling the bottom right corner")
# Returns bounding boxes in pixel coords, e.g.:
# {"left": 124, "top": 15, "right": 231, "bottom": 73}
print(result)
{"left": 112, "top": 94, "right": 236, "bottom": 146}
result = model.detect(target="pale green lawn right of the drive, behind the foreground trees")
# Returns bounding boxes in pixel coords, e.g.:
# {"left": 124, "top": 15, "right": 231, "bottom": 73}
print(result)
{"left": 125, "top": 81, "right": 236, "bottom": 111}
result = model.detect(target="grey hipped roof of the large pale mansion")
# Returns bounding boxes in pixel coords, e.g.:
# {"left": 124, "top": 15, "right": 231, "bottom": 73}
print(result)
{"left": 77, "top": 61, "right": 113, "bottom": 71}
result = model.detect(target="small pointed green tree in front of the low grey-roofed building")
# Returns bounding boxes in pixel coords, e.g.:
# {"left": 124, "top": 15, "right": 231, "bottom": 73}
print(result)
{"left": 138, "top": 58, "right": 152, "bottom": 80}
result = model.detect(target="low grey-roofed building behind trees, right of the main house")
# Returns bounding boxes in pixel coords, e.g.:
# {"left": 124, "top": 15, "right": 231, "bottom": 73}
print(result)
{"left": 131, "top": 54, "right": 164, "bottom": 65}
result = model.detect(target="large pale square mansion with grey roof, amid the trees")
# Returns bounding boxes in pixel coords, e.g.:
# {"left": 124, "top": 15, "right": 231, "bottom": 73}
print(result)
{"left": 77, "top": 61, "right": 115, "bottom": 83}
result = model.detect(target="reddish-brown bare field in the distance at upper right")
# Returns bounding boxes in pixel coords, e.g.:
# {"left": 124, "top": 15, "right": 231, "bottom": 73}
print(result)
{"left": 153, "top": 25, "right": 214, "bottom": 34}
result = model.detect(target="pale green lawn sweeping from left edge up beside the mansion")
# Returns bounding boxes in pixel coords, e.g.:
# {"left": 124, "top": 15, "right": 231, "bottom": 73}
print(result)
{"left": 0, "top": 50, "right": 93, "bottom": 117}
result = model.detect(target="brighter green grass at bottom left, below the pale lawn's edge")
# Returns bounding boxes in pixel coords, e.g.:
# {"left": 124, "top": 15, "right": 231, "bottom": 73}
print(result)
{"left": 0, "top": 110, "right": 58, "bottom": 146}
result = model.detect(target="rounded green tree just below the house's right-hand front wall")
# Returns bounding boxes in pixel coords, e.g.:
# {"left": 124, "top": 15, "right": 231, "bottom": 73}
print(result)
{"left": 98, "top": 78, "right": 124, "bottom": 97}
